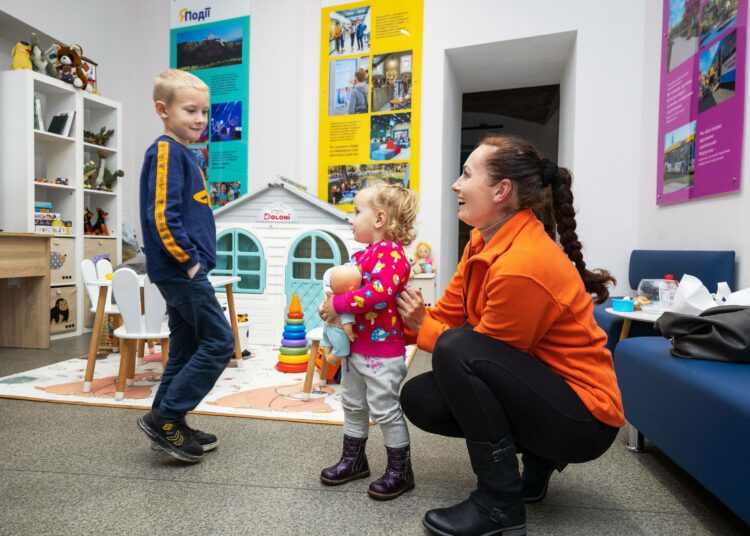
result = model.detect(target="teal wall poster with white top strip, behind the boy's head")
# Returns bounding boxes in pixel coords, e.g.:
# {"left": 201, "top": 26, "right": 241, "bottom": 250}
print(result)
{"left": 170, "top": 0, "right": 250, "bottom": 209}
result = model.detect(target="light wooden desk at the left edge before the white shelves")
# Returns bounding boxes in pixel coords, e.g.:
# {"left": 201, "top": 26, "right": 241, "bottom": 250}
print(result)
{"left": 0, "top": 233, "right": 50, "bottom": 349}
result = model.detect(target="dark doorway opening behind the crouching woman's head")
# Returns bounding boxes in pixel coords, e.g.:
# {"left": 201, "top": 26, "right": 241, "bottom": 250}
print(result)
{"left": 458, "top": 84, "right": 560, "bottom": 259}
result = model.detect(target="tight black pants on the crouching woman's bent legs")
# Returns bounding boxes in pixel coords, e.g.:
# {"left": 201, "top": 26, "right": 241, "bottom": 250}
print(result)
{"left": 401, "top": 327, "right": 618, "bottom": 463}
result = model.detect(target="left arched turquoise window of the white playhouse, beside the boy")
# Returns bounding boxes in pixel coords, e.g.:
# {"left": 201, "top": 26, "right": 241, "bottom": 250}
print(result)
{"left": 211, "top": 228, "right": 266, "bottom": 294}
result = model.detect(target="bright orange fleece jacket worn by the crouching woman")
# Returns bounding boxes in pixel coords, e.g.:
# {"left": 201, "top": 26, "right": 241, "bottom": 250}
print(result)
{"left": 414, "top": 210, "right": 625, "bottom": 427}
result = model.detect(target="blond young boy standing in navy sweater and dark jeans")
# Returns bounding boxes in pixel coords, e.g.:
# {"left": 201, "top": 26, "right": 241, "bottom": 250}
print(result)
{"left": 138, "top": 69, "right": 234, "bottom": 462}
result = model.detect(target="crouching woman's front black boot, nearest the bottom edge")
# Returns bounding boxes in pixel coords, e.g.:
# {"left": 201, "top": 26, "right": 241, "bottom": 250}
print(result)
{"left": 422, "top": 436, "right": 526, "bottom": 536}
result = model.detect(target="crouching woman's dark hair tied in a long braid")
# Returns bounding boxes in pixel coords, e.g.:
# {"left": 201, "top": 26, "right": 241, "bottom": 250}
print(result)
{"left": 480, "top": 135, "right": 617, "bottom": 303}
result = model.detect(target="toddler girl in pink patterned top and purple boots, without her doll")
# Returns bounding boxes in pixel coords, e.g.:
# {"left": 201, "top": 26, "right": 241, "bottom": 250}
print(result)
{"left": 320, "top": 182, "right": 417, "bottom": 500}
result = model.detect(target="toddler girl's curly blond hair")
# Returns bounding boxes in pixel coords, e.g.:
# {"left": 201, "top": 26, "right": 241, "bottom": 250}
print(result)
{"left": 357, "top": 181, "right": 417, "bottom": 247}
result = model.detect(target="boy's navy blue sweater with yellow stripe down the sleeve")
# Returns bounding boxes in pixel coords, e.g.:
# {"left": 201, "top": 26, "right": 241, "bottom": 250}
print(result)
{"left": 140, "top": 135, "right": 216, "bottom": 283}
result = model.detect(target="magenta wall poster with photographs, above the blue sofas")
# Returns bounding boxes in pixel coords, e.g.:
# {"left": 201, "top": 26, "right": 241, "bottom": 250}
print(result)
{"left": 656, "top": 0, "right": 747, "bottom": 205}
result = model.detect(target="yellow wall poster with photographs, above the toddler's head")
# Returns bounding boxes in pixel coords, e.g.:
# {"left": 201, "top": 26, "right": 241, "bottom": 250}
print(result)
{"left": 318, "top": 0, "right": 422, "bottom": 211}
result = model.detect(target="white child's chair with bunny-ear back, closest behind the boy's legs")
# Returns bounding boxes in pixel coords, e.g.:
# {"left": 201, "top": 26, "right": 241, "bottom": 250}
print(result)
{"left": 112, "top": 268, "right": 169, "bottom": 400}
